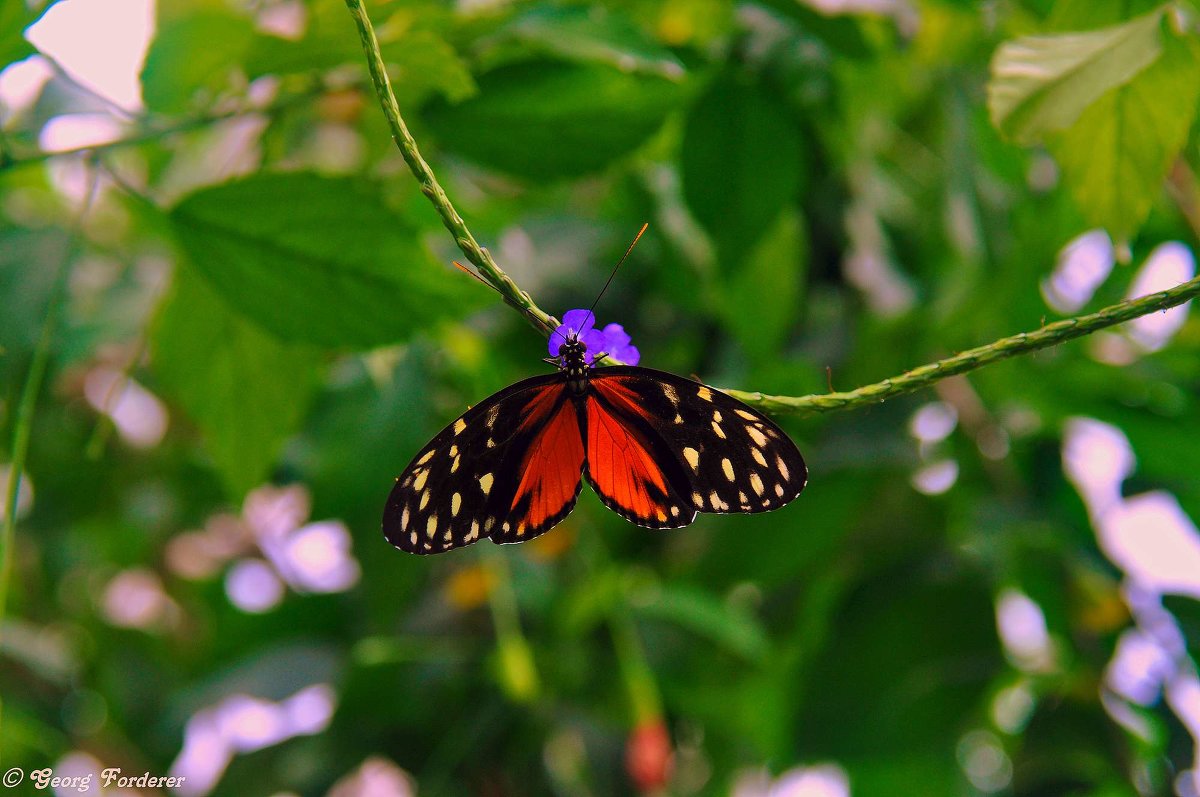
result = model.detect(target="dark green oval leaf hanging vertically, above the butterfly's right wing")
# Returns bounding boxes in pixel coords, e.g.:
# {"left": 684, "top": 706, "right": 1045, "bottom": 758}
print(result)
{"left": 680, "top": 74, "right": 804, "bottom": 268}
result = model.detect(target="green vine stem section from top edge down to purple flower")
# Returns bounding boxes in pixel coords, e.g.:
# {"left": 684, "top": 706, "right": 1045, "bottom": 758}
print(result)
{"left": 346, "top": 0, "right": 558, "bottom": 336}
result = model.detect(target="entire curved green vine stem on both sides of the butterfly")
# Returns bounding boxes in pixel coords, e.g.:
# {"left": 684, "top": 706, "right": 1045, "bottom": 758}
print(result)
{"left": 346, "top": 0, "right": 1200, "bottom": 414}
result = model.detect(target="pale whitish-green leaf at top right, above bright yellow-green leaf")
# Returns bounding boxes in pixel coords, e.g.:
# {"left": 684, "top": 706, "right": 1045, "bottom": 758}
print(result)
{"left": 988, "top": 8, "right": 1163, "bottom": 144}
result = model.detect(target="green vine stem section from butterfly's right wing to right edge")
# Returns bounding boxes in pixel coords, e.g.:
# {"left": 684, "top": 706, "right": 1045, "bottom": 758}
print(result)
{"left": 721, "top": 277, "right": 1200, "bottom": 415}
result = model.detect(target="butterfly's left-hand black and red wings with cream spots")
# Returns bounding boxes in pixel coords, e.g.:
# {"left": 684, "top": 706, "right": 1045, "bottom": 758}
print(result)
{"left": 383, "top": 373, "right": 583, "bottom": 555}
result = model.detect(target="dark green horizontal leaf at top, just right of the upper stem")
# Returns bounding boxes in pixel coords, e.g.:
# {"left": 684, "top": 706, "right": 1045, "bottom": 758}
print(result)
{"left": 427, "top": 61, "right": 683, "bottom": 179}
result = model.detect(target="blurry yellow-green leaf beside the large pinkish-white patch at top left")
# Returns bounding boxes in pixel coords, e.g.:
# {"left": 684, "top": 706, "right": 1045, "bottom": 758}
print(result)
{"left": 142, "top": 8, "right": 254, "bottom": 113}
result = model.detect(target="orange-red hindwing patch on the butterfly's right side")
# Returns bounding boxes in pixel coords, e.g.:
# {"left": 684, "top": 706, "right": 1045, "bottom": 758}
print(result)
{"left": 588, "top": 391, "right": 696, "bottom": 528}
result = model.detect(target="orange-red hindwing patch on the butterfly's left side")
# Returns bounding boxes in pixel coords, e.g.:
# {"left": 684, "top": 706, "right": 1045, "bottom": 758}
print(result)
{"left": 500, "top": 405, "right": 583, "bottom": 541}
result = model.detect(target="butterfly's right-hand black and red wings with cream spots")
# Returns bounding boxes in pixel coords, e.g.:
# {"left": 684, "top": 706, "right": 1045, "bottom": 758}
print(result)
{"left": 587, "top": 366, "right": 808, "bottom": 528}
